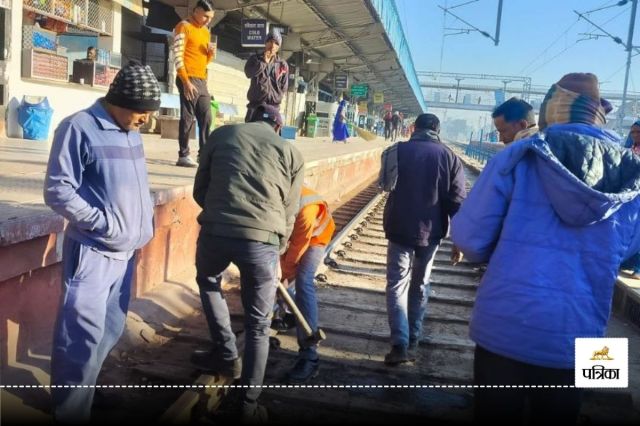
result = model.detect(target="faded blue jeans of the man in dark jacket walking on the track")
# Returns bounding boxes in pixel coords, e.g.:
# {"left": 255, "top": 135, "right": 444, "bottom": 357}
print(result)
{"left": 386, "top": 241, "right": 438, "bottom": 347}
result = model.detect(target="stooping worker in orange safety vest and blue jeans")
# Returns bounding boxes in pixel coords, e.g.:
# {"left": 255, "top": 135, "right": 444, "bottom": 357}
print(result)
{"left": 280, "top": 186, "right": 336, "bottom": 384}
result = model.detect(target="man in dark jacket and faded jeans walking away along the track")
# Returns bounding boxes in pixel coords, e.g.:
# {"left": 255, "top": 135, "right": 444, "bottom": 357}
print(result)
{"left": 381, "top": 114, "right": 466, "bottom": 365}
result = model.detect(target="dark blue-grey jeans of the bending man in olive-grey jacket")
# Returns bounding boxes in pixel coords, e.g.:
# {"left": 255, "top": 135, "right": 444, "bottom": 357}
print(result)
{"left": 196, "top": 236, "right": 279, "bottom": 404}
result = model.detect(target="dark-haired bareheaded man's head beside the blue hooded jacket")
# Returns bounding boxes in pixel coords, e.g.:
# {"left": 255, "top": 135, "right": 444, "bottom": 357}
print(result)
{"left": 491, "top": 98, "right": 538, "bottom": 145}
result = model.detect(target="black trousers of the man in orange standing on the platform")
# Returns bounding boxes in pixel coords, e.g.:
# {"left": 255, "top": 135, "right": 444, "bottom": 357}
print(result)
{"left": 176, "top": 77, "right": 211, "bottom": 157}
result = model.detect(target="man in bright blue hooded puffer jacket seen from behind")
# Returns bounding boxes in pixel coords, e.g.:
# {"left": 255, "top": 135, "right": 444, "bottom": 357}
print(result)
{"left": 451, "top": 74, "right": 640, "bottom": 424}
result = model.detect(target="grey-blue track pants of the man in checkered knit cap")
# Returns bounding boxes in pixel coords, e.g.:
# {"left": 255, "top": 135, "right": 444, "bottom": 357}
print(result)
{"left": 51, "top": 237, "right": 135, "bottom": 423}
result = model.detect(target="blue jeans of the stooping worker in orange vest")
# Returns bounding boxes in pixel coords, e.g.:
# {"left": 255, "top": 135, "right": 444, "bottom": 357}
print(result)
{"left": 295, "top": 246, "right": 325, "bottom": 360}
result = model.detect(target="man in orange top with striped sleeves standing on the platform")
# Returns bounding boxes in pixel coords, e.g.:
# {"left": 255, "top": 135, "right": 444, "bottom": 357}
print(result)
{"left": 173, "top": 0, "right": 216, "bottom": 167}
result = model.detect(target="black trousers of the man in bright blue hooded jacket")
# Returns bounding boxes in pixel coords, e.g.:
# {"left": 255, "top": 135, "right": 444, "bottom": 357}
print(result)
{"left": 473, "top": 346, "right": 582, "bottom": 425}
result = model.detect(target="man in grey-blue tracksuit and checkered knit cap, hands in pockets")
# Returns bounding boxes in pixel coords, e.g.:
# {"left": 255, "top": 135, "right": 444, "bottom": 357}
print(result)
{"left": 44, "top": 61, "right": 160, "bottom": 423}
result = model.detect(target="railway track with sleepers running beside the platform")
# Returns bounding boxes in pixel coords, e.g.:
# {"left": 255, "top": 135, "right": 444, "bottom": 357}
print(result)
{"left": 92, "top": 157, "right": 637, "bottom": 424}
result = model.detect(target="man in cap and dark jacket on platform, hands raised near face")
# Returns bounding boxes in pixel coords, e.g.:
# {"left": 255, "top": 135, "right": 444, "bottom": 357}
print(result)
{"left": 244, "top": 29, "right": 289, "bottom": 122}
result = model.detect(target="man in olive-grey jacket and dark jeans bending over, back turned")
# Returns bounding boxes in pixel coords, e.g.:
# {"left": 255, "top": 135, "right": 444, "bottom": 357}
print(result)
{"left": 191, "top": 105, "right": 304, "bottom": 420}
